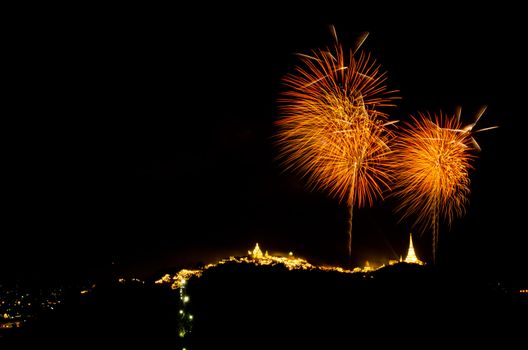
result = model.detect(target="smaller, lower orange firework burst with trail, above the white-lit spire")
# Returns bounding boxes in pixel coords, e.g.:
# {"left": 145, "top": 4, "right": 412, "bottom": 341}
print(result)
{"left": 391, "top": 109, "right": 495, "bottom": 262}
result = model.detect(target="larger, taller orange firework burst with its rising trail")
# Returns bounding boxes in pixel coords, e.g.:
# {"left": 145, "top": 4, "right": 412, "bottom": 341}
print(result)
{"left": 276, "top": 31, "right": 394, "bottom": 256}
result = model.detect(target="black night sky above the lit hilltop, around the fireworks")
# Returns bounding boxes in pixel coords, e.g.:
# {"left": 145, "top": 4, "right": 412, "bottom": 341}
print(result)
{"left": 5, "top": 4, "right": 528, "bottom": 277}
